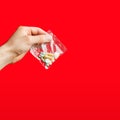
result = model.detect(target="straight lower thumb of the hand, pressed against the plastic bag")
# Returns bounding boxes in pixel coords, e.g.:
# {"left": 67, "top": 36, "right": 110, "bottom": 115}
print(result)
{"left": 29, "top": 35, "right": 52, "bottom": 45}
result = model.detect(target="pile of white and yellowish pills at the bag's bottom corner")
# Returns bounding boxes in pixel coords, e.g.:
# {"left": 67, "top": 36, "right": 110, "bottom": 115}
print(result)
{"left": 38, "top": 52, "right": 60, "bottom": 69}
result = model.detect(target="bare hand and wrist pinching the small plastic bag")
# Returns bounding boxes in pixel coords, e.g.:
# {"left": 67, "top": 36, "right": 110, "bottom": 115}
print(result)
{"left": 0, "top": 26, "right": 52, "bottom": 70}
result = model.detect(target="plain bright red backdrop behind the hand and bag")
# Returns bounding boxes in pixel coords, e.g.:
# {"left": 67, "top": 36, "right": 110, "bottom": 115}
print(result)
{"left": 0, "top": 0, "right": 120, "bottom": 120}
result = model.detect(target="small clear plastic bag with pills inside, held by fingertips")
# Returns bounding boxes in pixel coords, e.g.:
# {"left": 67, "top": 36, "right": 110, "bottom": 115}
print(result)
{"left": 30, "top": 31, "right": 67, "bottom": 69}
